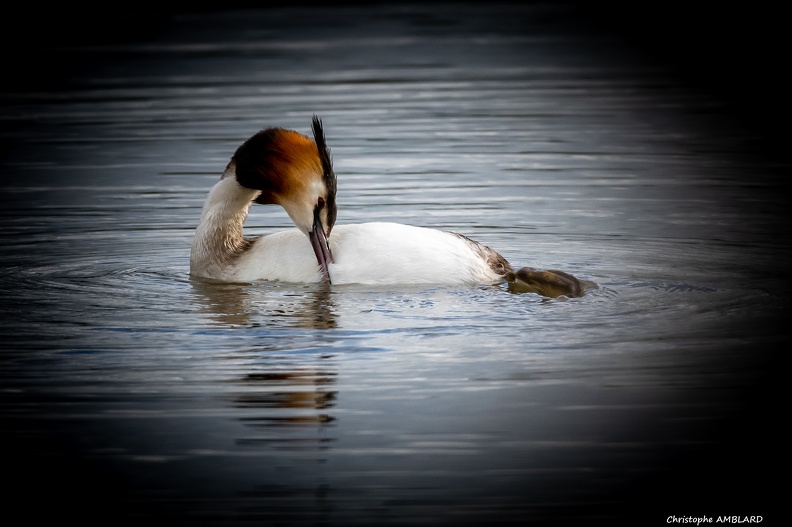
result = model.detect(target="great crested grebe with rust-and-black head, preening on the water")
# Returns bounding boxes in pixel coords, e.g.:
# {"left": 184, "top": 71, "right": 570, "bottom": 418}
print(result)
{"left": 190, "top": 116, "right": 581, "bottom": 296}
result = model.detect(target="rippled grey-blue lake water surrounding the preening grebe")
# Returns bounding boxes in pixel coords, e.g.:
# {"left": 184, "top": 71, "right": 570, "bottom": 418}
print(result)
{"left": 0, "top": 4, "right": 790, "bottom": 525}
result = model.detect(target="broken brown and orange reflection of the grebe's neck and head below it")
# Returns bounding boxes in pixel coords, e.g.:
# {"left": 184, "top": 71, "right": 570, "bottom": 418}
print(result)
{"left": 193, "top": 280, "right": 338, "bottom": 523}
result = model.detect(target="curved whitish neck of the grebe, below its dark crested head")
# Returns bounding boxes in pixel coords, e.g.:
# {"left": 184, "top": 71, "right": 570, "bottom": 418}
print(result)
{"left": 190, "top": 175, "right": 259, "bottom": 277}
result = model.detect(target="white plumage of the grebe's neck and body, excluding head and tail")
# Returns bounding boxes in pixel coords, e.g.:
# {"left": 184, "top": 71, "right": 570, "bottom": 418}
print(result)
{"left": 190, "top": 174, "right": 505, "bottom": 284}
